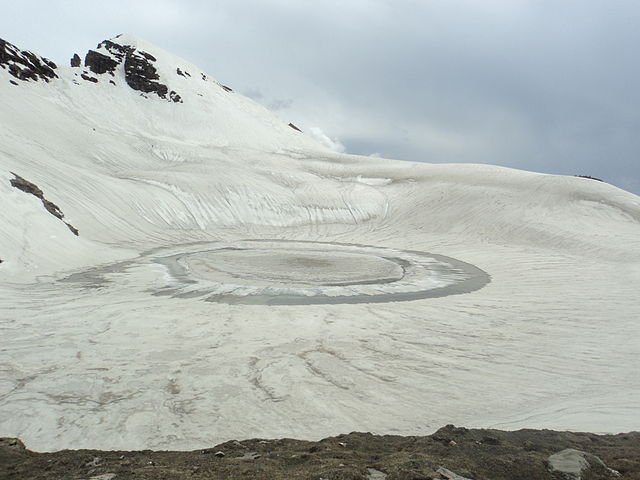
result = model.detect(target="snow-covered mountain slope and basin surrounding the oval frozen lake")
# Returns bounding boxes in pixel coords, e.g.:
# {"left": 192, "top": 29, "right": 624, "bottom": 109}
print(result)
{"left": 0, "top": 35, "right": 640, "bottom": 449}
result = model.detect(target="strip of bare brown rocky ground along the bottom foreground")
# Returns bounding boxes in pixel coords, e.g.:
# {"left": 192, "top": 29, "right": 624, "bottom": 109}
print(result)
{"left": 0, "top": 425, "right": 640, "bottom": 480}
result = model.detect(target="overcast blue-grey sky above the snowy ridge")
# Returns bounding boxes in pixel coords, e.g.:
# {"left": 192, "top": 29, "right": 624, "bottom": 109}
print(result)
{"left": 0, "top": 0, "right": 640, "bottom": 193}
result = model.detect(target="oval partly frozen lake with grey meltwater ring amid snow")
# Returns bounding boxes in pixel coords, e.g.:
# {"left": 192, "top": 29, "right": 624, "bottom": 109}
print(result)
{"left": 100, "top": 240, "right": 490, "bottom": 305}
